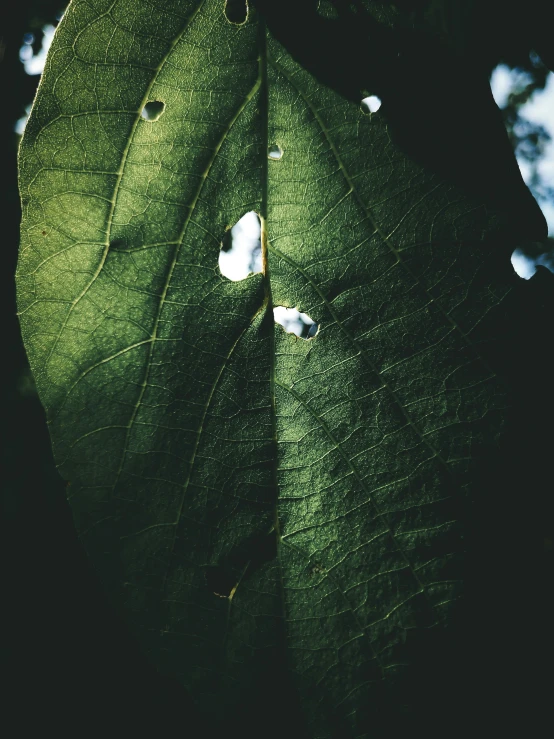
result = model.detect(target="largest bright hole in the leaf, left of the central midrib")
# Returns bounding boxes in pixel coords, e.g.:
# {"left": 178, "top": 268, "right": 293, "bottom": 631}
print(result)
{"left": 219, "top": 210, "right": 262, "bottom": 282}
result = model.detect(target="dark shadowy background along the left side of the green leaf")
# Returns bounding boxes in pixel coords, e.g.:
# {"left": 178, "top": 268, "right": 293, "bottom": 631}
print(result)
{"left": 0, "top": 0, "right": 204, "bottom": 736}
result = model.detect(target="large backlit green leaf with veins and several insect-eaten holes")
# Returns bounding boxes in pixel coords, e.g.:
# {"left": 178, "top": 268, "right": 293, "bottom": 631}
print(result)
{"left": 18, "top": 0, "right": 548, "bottom": 737}
